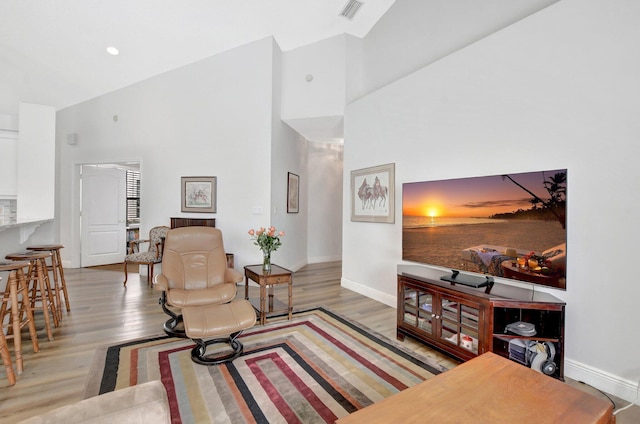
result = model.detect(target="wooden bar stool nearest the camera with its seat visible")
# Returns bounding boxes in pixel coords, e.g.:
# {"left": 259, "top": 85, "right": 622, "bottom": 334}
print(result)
{"left": 0, "top": 262, "right": 40, "bottom": 374}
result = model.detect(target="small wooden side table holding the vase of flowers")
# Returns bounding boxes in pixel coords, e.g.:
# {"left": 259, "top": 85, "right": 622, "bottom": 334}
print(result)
{"left": 244, "top": 264, "right": 293, "bottom": 325}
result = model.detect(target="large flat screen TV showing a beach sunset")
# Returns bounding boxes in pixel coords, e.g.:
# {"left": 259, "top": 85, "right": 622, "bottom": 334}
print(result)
{"left": 402, "top": 169, "right": 567, "bottom": 290}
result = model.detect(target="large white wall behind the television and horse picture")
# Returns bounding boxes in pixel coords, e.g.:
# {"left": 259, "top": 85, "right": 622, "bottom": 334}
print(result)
{"left": 343, "top": 0, "right": 640, "bottom": 400}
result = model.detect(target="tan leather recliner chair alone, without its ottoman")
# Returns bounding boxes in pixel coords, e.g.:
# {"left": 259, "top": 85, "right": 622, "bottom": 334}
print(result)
{"left": 154, "top": 227, "right": 243, "bottom": 337}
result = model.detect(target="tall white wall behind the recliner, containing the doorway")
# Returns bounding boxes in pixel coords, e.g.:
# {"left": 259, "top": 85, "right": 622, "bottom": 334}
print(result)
{"left": 56, "top": 38, "right": 280, "bottom": 268}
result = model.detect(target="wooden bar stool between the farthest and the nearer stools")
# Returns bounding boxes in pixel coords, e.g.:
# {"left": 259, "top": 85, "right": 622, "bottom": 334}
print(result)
{"left": 5, "top": 252, "right": 59, "bottom": 340}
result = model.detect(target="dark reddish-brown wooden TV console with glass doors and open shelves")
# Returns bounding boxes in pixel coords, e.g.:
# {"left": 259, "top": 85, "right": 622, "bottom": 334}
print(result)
{"left": 397, "top": 265, "right": 566, "bottom": 380}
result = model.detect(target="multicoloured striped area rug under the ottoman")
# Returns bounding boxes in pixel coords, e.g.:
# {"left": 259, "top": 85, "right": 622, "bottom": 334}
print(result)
{"left": 85, "top": 308, "right": 446, "bottom": 423}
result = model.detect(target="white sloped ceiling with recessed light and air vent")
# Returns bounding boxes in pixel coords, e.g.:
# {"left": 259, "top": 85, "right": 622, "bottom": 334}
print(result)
{"left": 0, "top": 0, "right": 395, "bottom": 115}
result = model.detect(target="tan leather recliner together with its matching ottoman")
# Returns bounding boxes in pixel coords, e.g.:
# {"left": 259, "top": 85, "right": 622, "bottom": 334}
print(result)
{"left": 154, "top": 227, "right": 256, "bottom": 365}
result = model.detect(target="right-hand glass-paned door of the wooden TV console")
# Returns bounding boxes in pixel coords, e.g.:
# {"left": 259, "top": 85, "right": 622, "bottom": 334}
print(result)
{"left": 440, "top": 296, "right": 480, "bottom": 354}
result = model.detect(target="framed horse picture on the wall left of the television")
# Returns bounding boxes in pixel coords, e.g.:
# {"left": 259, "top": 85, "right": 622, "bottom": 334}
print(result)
{"left": 351, "top": 163, "right": 396, "bottom": 223}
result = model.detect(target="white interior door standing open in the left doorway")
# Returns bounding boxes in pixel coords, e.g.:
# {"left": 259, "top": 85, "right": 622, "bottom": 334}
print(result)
{"left": 80, "top": 165, "right": 127, "bottom": 267}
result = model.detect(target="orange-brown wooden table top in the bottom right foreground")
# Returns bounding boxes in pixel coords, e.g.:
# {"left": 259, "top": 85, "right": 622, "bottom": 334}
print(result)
{"left": 336, "top": 352, "right": 615, "bottom": 424}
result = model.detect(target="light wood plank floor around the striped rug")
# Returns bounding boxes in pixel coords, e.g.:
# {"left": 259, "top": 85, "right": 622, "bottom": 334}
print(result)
{"left": 0, "top": 262, "right": 640, "bottom": 424}
